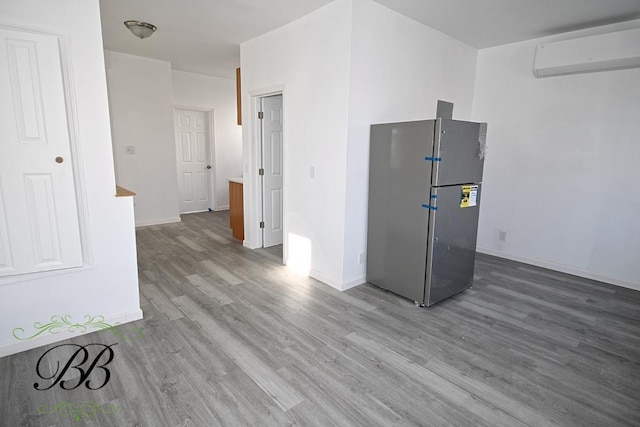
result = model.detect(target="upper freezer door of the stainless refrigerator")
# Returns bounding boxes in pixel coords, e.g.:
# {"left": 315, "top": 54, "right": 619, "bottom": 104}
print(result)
{"left": 432, "top": 119, "right": 487, "bottom": 186}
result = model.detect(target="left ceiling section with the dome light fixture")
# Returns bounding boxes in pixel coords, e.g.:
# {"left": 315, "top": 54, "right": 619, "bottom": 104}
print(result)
{"left": 100, "top": 0, "right": 331, "bottom": 78}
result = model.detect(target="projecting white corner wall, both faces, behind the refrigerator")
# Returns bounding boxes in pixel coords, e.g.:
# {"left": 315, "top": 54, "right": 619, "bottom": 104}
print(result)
{"left": 241, "top": 0, "right": 477, "bottom": 290}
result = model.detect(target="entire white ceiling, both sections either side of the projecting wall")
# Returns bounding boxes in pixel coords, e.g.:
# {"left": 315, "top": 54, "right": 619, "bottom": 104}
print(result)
{"left": 100, "top": 0, "right": 640, "bottom": 78}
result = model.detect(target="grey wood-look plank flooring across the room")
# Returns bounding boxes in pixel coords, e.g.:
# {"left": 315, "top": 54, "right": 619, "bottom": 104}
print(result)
{"left": 0, "top": 212, "right": 640, "bottom": 427}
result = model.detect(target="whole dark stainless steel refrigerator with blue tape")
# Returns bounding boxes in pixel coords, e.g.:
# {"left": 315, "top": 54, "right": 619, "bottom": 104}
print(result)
{"left": 367, "top": 118, "right": 487, "bottom": 306}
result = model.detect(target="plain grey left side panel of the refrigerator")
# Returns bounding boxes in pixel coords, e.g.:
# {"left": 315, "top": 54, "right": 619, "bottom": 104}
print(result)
{"left": 367, "top": 120, "right": 435, "bottom": 303}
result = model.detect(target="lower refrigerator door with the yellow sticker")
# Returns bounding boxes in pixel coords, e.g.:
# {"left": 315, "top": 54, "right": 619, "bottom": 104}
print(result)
{"left": 425, "top": 184, "right": 481, "bottom": 306}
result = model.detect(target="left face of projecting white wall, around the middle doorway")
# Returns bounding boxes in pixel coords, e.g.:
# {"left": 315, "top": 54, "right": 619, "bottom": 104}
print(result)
{"left": 240, "top": 0, "right": 351, "bottom": 288}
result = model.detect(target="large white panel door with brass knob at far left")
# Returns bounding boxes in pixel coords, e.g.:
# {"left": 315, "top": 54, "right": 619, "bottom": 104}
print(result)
{"left": 0, "top": 27, "right": 82, "bottom": 276}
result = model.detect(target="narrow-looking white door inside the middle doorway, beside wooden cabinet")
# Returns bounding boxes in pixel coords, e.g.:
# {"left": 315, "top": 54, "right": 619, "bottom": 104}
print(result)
{"left": 261, "top": 95, "right": 283, "bottom": 248}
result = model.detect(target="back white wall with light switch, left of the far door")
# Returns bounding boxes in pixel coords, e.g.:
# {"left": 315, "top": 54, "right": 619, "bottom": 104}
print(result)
{"left": 105, "top": 51, "right": 180, "bottom": 225}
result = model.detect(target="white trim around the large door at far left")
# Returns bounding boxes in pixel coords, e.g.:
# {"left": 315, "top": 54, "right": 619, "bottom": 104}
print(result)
{"left": 0, "top": 21, "right": 92, "bottom": 286}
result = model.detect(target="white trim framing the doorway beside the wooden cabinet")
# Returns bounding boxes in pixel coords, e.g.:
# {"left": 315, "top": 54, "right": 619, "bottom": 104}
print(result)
{"left": 248, "top": 86, "right": 288, "bottom": 263}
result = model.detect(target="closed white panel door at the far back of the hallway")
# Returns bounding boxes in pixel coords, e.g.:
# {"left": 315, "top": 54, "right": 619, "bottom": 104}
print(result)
{"left": 175, "top": 110, "right": 211, "bottom": 213}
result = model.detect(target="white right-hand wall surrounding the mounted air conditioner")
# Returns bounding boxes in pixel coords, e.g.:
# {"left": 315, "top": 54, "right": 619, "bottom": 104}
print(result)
{"left": 473, "top": 20, "right": 640, "bottom": 289}
